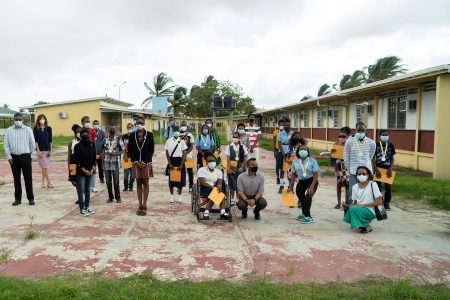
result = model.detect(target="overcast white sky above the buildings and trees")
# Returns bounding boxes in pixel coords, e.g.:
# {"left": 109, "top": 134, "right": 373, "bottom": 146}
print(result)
{"left": 0, "top": 0, "right": 450, "bottom": 108}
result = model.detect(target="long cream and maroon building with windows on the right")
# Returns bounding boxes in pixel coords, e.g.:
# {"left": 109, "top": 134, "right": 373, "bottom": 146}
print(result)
{"left": 253, "top": 64, "right": 450, "bottom": 179}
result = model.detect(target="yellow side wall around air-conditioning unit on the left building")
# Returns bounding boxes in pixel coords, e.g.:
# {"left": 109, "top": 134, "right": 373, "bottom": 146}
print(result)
{"left": 35, "top": 101, "right": 100, "bottom": 136}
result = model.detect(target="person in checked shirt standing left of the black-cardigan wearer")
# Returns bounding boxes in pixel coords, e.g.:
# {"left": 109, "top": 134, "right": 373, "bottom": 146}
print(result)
{"left": 102, "top": 126, "right": 122, "bottom": 203}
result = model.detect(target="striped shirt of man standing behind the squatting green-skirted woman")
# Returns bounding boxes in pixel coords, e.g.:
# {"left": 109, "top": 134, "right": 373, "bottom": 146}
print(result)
{"left": 344, "top": 137, "right": 376, "bottom": 175}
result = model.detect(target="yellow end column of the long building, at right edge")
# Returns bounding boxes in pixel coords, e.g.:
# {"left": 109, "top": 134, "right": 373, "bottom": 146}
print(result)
{"left": 433, "top": 74, "right": 450, "bottom": 179}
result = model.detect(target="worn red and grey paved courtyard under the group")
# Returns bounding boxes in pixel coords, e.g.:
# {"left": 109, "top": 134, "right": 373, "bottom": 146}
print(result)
{"left": 0, "top": 146, "right": 450, "bottom": 282}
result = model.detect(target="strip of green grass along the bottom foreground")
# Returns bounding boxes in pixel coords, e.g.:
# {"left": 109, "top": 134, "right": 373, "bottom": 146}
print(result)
{"left": 0, "top": 275, "right": 450, "bottom": 300}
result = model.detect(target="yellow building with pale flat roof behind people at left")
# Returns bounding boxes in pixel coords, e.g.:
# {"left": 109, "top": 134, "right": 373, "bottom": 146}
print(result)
{"left": 22, "top": 96, "right": 153, "bottom": 136}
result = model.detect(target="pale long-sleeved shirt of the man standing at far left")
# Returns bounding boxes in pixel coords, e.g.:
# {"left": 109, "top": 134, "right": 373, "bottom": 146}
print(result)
{"left": 4, "top": 125, "right": 36, "bottom": 159}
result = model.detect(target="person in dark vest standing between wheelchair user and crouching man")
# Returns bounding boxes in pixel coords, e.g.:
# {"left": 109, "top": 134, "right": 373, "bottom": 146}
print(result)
{"left": 225, "top": 132, "right": 248, "bottom": 203}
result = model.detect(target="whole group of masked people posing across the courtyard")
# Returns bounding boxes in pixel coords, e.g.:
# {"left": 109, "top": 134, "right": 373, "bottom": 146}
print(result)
{"left": 5, "top": 113, "right": 395, "bottom": 233}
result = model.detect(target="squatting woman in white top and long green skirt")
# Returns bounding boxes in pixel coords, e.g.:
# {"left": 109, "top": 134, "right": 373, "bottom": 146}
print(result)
{"left": 344, "top": 166, "right": 382, "bottom": 233}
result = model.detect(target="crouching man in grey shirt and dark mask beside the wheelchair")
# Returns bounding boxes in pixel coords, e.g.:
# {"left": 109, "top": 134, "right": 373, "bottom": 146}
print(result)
{"left": 237, "top": 158, "right": 267, "bottom": 220}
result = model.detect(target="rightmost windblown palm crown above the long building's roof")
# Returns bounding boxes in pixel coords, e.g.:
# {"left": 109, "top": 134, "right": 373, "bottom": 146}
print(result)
{"left": 366, "top": 56, "right": 407, "bottom": 83}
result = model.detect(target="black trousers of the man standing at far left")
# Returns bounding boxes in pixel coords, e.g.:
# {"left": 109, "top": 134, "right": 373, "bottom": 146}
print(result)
{"left": 11, "top": 154, "right": 34, "bottom": 202}
